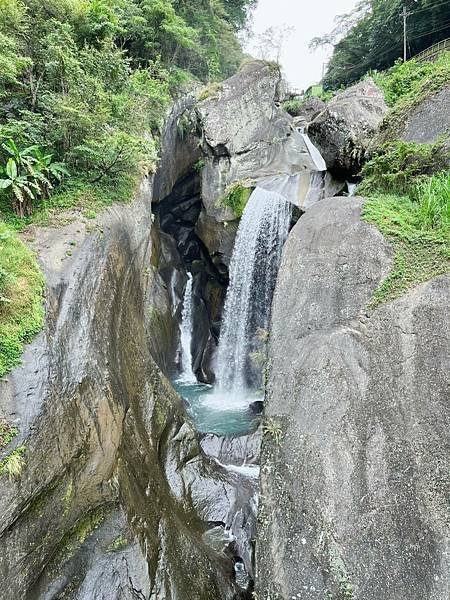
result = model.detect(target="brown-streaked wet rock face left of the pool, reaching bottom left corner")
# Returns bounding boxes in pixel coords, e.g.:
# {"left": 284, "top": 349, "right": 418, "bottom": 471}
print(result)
{"left": 0, "top": 187, "right": 254, "bottom": 600}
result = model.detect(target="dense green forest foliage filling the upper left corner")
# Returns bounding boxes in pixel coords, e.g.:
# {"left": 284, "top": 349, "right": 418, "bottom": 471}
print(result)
{"left": 0, "top": 0, "right": 254, "bottom": 216}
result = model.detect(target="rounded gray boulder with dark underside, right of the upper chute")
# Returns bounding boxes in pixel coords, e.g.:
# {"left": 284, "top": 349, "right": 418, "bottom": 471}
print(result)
{"left": 308, "top": 79, "right": 387, "bottom": 179}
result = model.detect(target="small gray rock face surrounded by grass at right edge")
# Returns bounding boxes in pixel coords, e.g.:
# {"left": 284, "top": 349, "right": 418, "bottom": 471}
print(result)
{"left": 400, "top": 85, "right": 450, "bottom": 148}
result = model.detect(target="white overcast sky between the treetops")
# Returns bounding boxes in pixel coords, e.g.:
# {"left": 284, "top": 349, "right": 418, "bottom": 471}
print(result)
{"left": 247, "top": 0, "right": 357, "bottom": 90}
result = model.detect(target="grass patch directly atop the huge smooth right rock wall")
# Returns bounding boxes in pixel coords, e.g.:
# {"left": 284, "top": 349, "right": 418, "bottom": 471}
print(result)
{"left": 363, "top": 185, "right": 450, "bottom": 309}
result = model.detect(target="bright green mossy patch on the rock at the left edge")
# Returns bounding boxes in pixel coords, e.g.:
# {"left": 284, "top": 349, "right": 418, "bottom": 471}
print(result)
{"left": 0, "top": 221, "right": 44, "bottom": 377}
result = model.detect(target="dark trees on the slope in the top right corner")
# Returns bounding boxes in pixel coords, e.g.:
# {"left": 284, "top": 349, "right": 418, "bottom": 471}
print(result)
{"left": 311, "top": 0, "right": 450, "bottom": 89}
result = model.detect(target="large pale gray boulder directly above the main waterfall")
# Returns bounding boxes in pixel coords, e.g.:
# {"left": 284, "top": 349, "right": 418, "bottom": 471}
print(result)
{"left": 196, "top": 61, "right": 316, "bottom": 222}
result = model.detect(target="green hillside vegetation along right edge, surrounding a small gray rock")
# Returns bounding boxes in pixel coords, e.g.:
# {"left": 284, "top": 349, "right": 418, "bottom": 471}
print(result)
{"left": 358, "top": 52, "right": 450, "bottom": 307}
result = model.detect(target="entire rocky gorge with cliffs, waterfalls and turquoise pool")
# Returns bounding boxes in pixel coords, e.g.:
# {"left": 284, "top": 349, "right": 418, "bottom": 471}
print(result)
{"left": 0, "top": 54, "right": 450, "bottom": 600}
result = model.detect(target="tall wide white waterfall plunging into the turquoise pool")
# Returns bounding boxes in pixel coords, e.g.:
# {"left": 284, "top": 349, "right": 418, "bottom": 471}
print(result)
{"left": 217, "top": 188, "right": 292, "bottom": 392}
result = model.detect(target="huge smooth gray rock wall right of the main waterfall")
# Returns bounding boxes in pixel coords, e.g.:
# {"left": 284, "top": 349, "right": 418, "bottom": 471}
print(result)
{"left": 257, "top": 198, "right": 450, "bottom": 600}
